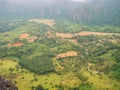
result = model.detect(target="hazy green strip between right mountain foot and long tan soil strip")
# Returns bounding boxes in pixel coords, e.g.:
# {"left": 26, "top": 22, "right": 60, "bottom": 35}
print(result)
{"left": 54, "top": 20, "right": 120, "bottom": 33}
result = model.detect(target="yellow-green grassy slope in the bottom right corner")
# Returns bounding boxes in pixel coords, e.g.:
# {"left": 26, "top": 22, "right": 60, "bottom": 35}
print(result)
{"left": 84, "top": 71, "right": 120, "bottom": 90}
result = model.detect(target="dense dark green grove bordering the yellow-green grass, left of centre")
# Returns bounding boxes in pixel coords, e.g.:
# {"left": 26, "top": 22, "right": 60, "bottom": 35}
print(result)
{"left": 19, "top": 56, "right": 54, "bottom": 74}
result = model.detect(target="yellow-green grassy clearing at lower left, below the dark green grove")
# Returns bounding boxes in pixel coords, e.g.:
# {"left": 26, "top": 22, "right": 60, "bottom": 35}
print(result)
{"left": 0, "top": 60, "right": 61, "bottom": 90}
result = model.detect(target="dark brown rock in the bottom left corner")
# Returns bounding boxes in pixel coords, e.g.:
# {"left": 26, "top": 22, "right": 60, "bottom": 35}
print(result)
{"left": 0, "top": 76, "right": 18, "bottom": 90}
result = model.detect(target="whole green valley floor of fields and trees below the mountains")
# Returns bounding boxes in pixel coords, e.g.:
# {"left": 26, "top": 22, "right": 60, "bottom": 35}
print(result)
{"left": 0, "top": 21, "right": 120, "bottom": 90}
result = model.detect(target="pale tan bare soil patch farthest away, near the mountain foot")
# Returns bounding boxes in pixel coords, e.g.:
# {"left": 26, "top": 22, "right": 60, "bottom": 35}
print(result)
{"left": 28, "top": 19, "right": 55, "bottom": 27}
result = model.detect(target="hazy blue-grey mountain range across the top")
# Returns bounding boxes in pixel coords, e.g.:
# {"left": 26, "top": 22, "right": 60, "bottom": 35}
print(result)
{"left": 0, "top": 0, "right": 120, "bottom": 26}
